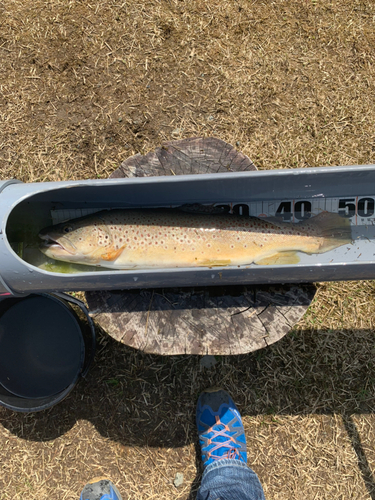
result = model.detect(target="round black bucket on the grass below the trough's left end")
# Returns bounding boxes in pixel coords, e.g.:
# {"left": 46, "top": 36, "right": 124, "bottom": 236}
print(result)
{"left": 0, "top": 293, "right": 95, "bottom": 412}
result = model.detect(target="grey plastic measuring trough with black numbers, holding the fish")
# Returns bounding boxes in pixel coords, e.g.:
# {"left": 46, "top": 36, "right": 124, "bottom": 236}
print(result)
{"left": 0, "top": 165, "right": 375, "bottom": 295}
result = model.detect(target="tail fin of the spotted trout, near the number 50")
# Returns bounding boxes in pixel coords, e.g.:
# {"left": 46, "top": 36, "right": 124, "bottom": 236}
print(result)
{"left": 302, "top": 212, "right": 352, "bottom": 253}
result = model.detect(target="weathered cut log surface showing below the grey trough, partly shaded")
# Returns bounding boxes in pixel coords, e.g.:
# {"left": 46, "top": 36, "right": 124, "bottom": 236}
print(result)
{"left": 87, "top": 285, "right": 315, "bottom": 355}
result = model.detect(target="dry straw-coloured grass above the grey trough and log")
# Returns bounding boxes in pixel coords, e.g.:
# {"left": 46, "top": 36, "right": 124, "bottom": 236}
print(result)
{"left": 0, "top": 0, "right": 375, "bottom": 181}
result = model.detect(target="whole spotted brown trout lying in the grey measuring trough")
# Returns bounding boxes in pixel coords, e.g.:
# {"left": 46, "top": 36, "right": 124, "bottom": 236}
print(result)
{"left": 39, "top": 209, "right": 352, "bottom": 269}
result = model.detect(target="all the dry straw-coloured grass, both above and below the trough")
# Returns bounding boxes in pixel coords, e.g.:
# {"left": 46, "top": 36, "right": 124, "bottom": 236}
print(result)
{"left": 0, "top": 0, "right": 375, "bottom": 500}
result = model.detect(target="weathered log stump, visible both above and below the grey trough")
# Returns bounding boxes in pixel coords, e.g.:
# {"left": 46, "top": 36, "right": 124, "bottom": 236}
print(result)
{"left": 86, "top": 138, "right": 315, "bottom": 355}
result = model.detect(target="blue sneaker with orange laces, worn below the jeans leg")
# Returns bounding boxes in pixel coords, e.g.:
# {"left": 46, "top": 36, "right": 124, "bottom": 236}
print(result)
{"left": 196, "top": 387, "right": 247, "bottom": 467}
